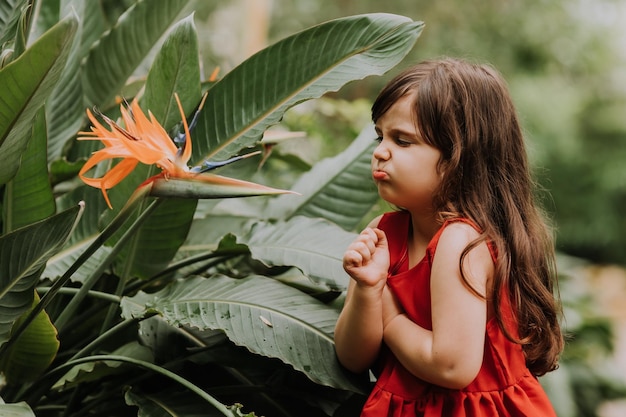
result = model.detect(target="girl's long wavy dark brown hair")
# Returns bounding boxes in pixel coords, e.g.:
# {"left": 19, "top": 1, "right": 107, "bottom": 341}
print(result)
{"left": 372, "top": 58, "right": 563, "bottom": 375}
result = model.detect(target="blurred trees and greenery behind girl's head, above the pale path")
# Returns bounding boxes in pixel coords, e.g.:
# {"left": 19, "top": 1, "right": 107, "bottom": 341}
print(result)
{"left": 196, "top": 0, "right": 626, "bottom": 264}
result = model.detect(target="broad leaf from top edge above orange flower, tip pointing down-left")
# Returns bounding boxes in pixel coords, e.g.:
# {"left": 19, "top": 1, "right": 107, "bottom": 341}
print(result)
{"left": 81, "top": 0, "right": 188, "bottom": 106}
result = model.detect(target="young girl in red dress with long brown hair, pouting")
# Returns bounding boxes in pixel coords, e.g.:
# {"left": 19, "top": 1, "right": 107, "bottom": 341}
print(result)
{"left": 335, "top": 59, "right": 563, "bottom": 417}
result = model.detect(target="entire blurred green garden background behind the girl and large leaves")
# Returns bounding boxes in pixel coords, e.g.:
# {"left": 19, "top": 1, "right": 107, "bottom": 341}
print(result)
{"left": 114, "top": 0, "right": 626, "bottom": 417}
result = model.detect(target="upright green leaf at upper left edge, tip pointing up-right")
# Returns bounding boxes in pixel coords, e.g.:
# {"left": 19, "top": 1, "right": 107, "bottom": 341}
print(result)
{"left": 0, "top": 17, "right": 77, "bottom": 184}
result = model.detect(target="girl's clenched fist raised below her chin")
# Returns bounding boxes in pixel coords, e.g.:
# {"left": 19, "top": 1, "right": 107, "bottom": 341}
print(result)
{"left": 343, "top": 227, "right": 389, "bottom": 287}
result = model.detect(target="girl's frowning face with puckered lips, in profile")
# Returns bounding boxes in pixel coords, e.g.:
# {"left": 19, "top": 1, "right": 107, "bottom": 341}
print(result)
{"left": 372, "top": 94, "right": 441, "bottom": 214}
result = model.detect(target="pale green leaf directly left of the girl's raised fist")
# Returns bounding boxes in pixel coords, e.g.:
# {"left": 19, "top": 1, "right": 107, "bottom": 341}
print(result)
{"left": 237, "top": 216, "right": 356, "bottom": 290}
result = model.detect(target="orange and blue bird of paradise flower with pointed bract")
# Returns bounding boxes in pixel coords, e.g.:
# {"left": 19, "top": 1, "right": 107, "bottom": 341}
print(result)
{"left": 77, "top": 94, "right": 290, "bottom": 208}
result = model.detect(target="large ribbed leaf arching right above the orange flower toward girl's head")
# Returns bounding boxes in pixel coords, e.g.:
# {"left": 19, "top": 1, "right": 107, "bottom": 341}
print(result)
{"left": 193, "top": 14, "right": 423, "bottom": 165}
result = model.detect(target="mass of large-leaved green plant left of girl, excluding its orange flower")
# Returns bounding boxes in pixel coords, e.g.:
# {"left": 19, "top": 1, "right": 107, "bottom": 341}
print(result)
{"left": 0, "top": 0, "right": 422, "bottom": 416}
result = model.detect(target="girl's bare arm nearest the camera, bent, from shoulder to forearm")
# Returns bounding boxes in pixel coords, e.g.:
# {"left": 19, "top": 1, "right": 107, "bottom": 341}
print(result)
{"left": 384, "top": 223, "right": 494, "bottom": 389}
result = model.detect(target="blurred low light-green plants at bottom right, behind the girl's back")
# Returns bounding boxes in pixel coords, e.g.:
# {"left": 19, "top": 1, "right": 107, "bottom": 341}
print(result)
{"left": 541, "top": 254, "right": 626, "bottom": 417}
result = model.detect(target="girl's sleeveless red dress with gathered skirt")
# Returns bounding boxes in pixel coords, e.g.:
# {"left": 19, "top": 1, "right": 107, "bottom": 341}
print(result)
{"left": 361, "top": 212, "right": 556, "bottom": 417}
